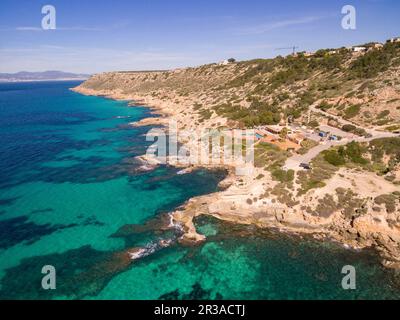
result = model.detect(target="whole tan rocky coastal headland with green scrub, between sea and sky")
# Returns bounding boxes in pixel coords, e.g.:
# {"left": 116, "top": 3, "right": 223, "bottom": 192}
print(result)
{"left": 73, "top": 44, "right": 400, "bottom": 268}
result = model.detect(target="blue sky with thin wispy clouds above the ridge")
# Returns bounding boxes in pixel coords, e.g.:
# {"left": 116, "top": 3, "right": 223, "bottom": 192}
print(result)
{"left": 0, "top": 0, "right": 400, "bottom": 73}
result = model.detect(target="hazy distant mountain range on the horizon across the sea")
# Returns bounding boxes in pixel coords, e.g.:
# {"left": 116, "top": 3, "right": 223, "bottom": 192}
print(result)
{"left": 0, "top": 71, "right": 90, "bottom": 82}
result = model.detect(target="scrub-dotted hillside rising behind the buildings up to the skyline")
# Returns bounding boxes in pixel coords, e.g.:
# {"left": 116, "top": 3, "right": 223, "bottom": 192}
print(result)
{"left": 82, "top": 43, "right": 400, "bottom": 130}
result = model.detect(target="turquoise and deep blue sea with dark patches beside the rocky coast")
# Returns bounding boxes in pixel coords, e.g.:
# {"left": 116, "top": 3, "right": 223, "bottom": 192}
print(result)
{"left": 0, "top": 82, "right": 400, "bottom": 299}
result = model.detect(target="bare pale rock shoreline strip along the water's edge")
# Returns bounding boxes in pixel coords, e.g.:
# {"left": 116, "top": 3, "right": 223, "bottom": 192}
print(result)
{"left": 72, "top": 75, "right": 400, "bottom": 269}
